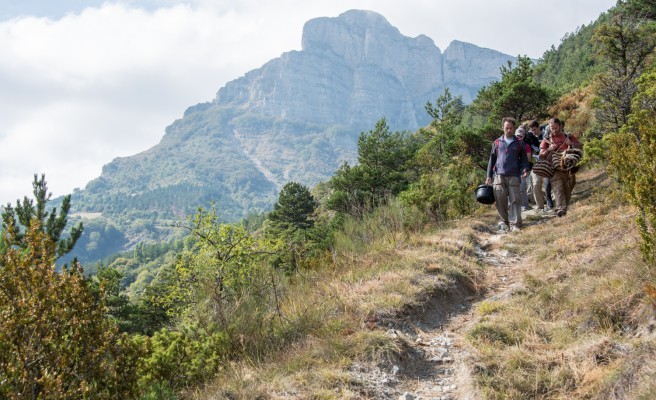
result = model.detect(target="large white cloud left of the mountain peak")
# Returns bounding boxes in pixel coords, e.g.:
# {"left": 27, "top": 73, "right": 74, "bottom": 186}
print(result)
{"left": 0, "top": 5, "right": 279, "bottom": 204}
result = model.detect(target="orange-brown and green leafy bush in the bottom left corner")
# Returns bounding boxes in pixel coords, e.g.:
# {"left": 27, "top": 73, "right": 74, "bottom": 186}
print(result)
{"left": 0, "top": 216, "right": 142, "bottom": 399}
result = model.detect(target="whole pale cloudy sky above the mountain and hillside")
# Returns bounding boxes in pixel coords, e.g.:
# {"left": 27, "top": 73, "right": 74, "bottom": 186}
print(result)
{"left": 0, "top": 0, "right": 615, "bottom": 204}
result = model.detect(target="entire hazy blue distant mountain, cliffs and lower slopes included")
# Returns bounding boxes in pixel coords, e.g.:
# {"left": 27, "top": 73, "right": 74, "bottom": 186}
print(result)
{"left": 69, "top": 10, "right": 514, "bottom": 260}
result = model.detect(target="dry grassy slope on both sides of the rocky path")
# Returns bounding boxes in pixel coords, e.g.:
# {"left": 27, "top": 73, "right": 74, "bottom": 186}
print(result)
{"left": 188, "top": 167, "right": 656, "bottom": 399}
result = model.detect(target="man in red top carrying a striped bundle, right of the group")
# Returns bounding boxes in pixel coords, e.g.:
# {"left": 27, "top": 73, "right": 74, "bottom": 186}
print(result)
{"left": 540, "top": 118, "right": 583, "bottom": 217}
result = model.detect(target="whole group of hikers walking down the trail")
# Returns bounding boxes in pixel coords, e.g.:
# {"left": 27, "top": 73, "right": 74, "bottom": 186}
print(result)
{"left": 485, "top": 117, "right": 583, "bottom": 232}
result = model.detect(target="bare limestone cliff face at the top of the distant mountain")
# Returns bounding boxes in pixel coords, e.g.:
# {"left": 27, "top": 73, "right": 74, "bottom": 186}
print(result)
{"left": 215, "top": 10, "right": 514, "bottom": 129}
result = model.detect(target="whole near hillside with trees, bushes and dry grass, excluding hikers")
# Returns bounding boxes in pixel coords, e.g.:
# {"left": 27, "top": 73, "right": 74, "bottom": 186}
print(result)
{"left": 0, "top": 0, "right": 656, "bottom": 399}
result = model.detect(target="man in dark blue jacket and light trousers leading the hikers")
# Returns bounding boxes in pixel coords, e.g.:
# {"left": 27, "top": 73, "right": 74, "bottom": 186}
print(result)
{"left": 485, "top": 117, "right": 530, "bottom": 232}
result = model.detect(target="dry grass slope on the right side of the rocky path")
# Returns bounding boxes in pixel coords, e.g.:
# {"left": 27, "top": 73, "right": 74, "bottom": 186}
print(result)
{"left": 469, "top": 168, "right": 656, "bottom": 399}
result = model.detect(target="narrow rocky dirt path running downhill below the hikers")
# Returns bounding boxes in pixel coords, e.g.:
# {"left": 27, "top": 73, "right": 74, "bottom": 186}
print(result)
{"left": 385, "top": 228, "right": 526, "bottom": 400}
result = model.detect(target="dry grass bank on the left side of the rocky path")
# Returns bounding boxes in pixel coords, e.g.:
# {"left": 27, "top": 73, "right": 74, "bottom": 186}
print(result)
{"left": 191, "top": 203, "right": 482, "bottom": 399}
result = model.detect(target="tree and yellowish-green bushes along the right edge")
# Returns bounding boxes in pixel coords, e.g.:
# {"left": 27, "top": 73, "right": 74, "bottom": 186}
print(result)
{"left": 596, "top": 0, "right": 656, "bottom": 266}
